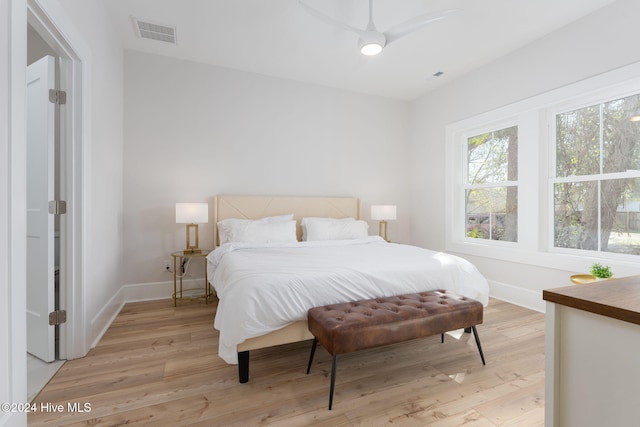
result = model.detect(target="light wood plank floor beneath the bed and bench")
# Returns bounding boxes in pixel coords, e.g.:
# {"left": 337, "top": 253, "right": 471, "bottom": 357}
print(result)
{"left": 28, "top": 300, "right": 544, "bottom": 427}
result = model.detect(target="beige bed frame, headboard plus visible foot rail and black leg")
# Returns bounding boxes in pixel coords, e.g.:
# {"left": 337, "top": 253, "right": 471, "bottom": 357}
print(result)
{"left": 214, "top": 195, "right": 360, "bottom": 383}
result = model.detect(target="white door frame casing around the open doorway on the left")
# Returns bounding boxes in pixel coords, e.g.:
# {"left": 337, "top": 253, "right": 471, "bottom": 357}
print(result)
{"left": 25, "top": 0, "right": 90, "bottom": 359}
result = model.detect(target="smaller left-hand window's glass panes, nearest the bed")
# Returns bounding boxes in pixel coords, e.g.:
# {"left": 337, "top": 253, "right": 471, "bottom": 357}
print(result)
{"left": 465, "top": 126, "right": 518, "bottom": 242}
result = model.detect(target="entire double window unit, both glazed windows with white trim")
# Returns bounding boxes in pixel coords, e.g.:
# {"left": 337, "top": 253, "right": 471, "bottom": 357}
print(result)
{"left": 450, "top": 63, "right": 640, "bottom": 274}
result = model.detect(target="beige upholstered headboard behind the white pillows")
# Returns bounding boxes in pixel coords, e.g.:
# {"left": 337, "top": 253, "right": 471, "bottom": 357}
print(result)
{"left": 214, "top": 195, "right": 360, "bottom": 245}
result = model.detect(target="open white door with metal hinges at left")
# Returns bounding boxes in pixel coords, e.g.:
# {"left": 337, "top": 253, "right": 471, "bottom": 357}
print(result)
{"left": 27, "top": 56, "right": 55, "bottom": 362}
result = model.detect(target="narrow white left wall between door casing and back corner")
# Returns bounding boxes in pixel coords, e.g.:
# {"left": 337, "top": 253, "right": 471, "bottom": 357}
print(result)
{"left": 59, "top": 0, "right": 123, "bottom": 344}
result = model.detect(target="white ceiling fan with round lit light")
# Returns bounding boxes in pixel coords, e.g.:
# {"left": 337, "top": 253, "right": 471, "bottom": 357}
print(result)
{"left": 298, "top": 0, "right": 460, "bottom": 56}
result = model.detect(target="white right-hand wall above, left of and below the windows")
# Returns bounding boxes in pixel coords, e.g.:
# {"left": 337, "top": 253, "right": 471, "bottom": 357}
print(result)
{"left": 410, "top": 0, "right": 640, "bottom": 307}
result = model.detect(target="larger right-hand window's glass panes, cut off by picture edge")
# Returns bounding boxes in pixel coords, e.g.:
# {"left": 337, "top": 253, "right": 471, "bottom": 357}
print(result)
{"left": 550, "top": 95, "right": 640, "bottom": 255}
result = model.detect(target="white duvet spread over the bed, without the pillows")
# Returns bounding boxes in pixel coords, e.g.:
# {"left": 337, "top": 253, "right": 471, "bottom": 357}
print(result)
{"left": 207, "top": 236, "right": 489, "bottom": 363}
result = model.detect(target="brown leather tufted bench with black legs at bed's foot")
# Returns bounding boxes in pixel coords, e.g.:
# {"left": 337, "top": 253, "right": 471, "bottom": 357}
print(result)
{"left": 307, "top": 291, "right": 485, "bottom": 409}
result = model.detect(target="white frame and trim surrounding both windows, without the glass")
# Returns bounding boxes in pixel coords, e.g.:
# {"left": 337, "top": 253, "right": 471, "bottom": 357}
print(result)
{"left": 445, "top": 62, "right": 640, "bottom": 272}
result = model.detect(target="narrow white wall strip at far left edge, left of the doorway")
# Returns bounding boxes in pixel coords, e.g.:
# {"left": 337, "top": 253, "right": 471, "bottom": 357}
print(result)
{"left": 0, "top": 0, "right": 27, "bottom": 426}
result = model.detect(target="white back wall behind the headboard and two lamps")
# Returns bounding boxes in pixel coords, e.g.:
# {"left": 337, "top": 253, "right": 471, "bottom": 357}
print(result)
{"left": 124, "top": 51, "right": 410, "bottom": 290}
